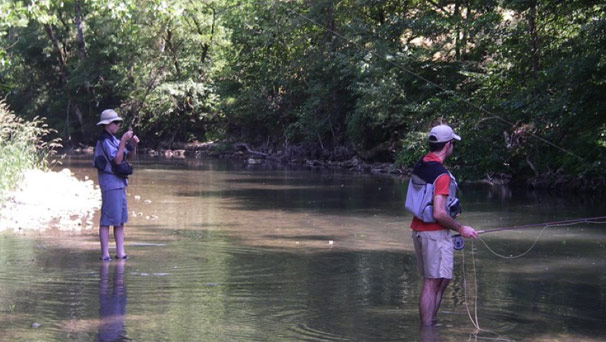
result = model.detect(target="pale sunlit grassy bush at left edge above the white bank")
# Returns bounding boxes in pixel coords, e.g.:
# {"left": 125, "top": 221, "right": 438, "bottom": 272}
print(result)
{"left": 0, "top": 101, "right": 58, "bottom": 202}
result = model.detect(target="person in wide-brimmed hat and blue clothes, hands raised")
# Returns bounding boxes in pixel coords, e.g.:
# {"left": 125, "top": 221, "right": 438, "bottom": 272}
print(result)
{"left": 94, "top": 109, "right": 139, "bottom": 261}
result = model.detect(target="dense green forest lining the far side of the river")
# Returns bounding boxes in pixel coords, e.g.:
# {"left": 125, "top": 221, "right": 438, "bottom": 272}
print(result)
{"left": 0, "top": 0, "right": 606, "bottom": 188}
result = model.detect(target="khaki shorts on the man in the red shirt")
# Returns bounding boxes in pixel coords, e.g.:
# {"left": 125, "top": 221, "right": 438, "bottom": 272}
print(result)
{"left": 412, "top": 229, "right": 454, "bottom": 279}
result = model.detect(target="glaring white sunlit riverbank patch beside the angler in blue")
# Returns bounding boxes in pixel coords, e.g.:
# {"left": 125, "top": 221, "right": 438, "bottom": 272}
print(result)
{"left": 0, "top": 169, "right": 101, "bottom": 232}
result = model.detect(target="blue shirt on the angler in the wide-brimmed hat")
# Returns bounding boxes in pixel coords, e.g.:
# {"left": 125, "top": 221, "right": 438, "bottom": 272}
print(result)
{"left": 93, "top": 131, "right": 128, "bottom": 191}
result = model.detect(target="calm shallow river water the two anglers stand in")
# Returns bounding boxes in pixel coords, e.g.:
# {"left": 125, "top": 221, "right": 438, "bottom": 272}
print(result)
{"left": 0, "top": 157, "right": 606, "bottom": 342}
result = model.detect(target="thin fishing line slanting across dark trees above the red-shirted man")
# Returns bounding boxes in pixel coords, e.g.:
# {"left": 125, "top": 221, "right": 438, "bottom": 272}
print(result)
{"left": 273, "top": 0, "right": 585, "bottom": 161}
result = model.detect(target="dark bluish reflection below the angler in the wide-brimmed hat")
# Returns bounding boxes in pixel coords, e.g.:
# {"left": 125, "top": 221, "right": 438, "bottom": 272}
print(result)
{"left": 97, "top": 260, "right": 130, "bottom": 342}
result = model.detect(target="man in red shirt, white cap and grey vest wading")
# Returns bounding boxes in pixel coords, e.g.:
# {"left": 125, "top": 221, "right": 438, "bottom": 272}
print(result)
{"left": 406, "top": 125, "right": 478, "bottom": 325}
